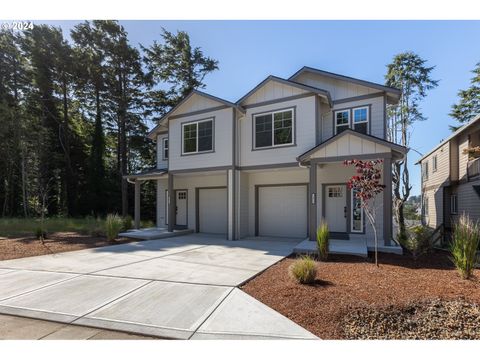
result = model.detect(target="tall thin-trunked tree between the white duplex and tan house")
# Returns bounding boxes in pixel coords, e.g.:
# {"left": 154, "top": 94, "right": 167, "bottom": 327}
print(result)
{"left": 385, "top": 52, "right": 438, "bottom": 236}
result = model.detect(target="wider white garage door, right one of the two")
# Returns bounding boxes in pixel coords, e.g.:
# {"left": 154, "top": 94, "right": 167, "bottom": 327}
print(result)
{"left": 258, "top": 185, "right": 308, "bottom": 238}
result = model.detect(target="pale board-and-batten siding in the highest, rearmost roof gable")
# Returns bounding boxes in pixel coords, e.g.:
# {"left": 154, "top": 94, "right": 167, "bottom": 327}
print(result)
{"left": 294, "top": 72, "right": 379, "bottom": 100}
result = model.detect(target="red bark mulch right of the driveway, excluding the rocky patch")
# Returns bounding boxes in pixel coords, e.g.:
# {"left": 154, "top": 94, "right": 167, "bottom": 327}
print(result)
{"left": 242, "top": 251, "right": 480, "bottom": 339}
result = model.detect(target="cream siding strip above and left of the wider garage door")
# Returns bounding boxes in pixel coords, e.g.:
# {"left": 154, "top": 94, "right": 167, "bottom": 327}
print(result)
{"left": 244, "top": 168, "right": 309, "bottom": 236}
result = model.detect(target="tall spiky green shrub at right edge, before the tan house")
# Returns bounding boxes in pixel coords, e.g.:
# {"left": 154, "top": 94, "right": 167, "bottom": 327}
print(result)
{"left": 450, "top": 215, "right": 480, "bottom": 279}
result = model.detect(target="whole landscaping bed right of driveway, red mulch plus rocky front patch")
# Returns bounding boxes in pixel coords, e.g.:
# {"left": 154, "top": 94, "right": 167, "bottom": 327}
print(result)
{"left": 242, "top": 251, "right": 480, "bottom": 339}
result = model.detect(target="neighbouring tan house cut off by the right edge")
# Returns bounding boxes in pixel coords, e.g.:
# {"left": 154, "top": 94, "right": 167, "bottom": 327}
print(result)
{"left": 417, "top": 115, "right": 480, "bottom": 232}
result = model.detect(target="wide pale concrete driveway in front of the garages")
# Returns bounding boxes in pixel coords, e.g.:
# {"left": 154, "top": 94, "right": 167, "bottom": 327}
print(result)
{"left": 0, "top": 234, "right": 316, "bottom": 339}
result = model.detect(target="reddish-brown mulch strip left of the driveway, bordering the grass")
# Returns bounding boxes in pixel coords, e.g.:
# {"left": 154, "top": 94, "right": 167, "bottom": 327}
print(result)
{"left": 0, "top": 232, "right": 138, "bottom": 260}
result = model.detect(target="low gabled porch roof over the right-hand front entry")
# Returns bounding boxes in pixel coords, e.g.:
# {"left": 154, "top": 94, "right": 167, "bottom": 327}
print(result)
{"left": 297, "top": 129, "right": 408, "bottom": 162}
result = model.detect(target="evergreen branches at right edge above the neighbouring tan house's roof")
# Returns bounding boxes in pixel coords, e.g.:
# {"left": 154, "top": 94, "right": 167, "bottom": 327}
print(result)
{"left": 450, "top": 62, "right": 480, "bottom": 131}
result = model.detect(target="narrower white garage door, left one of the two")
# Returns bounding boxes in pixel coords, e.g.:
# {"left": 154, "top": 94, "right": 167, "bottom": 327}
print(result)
{"left": 198, "top": 188, "right": 227, "bottom": 234}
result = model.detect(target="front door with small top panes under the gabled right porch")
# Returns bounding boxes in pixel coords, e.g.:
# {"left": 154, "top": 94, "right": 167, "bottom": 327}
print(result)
{"left": 325, "top": 185, "right": 347, "bottom": 232}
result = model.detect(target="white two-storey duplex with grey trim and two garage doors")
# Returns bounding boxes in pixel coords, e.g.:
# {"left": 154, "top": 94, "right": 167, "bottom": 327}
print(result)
{"left": 128, "top": 67, "right": 406, "bottom": 251}
